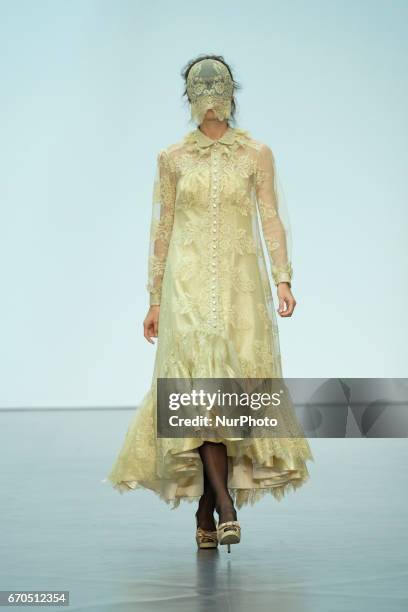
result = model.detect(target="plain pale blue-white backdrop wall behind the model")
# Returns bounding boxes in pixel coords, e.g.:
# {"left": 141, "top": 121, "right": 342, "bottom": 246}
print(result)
{"left": 0, "top": 0, "right": 408, "bottom": 407}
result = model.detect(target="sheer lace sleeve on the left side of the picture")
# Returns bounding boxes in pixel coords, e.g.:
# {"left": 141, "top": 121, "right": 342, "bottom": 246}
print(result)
{"left": 146, "top": 149, "right": 176, "bottom": 306}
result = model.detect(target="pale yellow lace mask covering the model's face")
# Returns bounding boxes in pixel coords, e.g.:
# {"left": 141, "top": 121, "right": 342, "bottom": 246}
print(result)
{"left": 187, "top": 59, "right": 234, "bottom": 125}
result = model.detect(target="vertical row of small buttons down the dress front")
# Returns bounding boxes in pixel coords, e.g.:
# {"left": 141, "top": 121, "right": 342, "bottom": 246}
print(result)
{"left": 210, "top": 143, "right": 219, "bottom": 328}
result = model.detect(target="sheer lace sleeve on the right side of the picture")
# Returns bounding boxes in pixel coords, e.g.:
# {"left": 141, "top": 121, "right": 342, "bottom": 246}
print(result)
{"left": 255, "top": 144, "right": 293, "bottom": 285}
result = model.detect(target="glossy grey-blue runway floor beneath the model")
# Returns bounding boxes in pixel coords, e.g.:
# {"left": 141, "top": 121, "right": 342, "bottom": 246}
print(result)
{"left": 0, "top": 410, "right": 408, "bottom": 612}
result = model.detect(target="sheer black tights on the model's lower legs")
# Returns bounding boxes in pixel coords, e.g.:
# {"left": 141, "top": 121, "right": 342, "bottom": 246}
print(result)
{"left": 197, "top": 442, "right": 237, "bottom": 530}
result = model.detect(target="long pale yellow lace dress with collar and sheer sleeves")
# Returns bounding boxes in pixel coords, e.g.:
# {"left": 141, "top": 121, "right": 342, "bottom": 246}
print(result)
{"left": 103, "top": 126, "right": 313, "bottom": 508}
